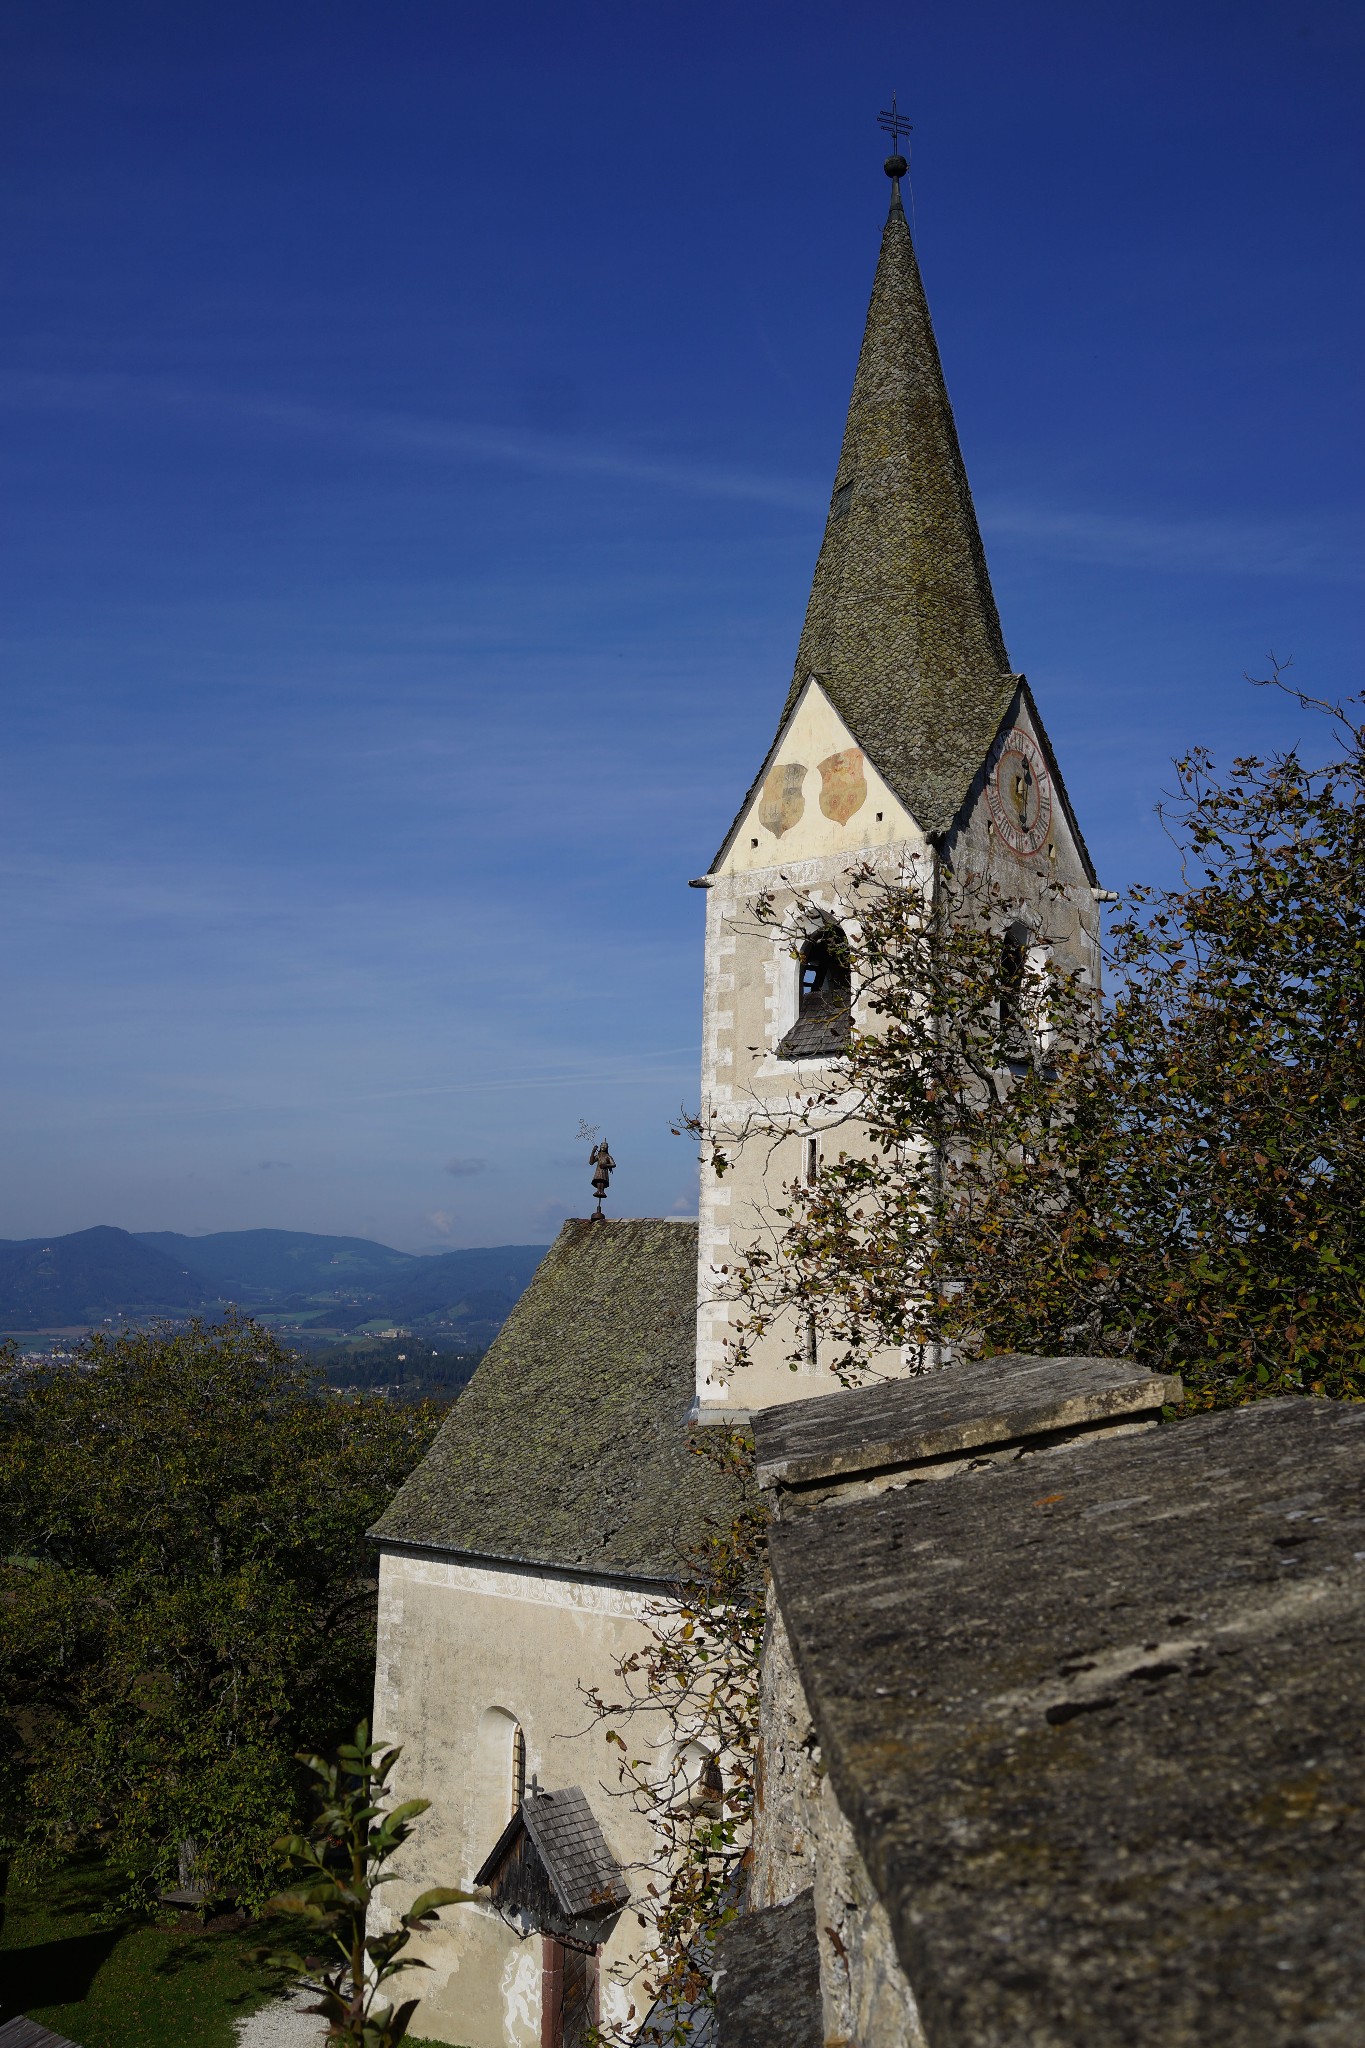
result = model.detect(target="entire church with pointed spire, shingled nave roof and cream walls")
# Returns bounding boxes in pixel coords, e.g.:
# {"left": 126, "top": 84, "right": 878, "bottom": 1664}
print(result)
{"left": 375, "top": 158, "right": 1099, "bottom": 2048}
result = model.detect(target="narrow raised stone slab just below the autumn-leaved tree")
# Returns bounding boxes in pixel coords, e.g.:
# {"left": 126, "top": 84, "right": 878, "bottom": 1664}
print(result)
{"left": 753, "top": 1352, "right": 1181, "bottom": 1489}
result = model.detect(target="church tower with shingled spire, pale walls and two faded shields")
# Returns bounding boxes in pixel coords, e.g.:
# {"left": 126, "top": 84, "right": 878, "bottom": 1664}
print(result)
{"left": 696, "top": 156, "right": 1099, "bottom": 1421}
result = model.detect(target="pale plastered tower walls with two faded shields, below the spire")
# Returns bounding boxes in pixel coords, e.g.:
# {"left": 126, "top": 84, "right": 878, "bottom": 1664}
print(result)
{"left": 698, "top": 680, "right": 1099, "bottom": 1421}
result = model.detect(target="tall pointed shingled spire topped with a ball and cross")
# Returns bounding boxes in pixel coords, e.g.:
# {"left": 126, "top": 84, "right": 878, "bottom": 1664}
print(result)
{"left": 784, "top": 156, "right": 1017, "bottom": 834}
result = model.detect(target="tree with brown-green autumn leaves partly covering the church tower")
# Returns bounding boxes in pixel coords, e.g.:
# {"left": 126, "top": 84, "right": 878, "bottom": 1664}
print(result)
{"left": 712, "top": 678, "right": 1365, "bottom": 1407}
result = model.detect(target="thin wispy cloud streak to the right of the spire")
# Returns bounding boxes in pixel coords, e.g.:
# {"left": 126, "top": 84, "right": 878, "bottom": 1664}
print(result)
{"left": 980, "top": 500, "right": 1365, "bottom": 584}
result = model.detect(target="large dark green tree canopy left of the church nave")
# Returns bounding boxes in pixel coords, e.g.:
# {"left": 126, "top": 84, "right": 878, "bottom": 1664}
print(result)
{"left": 0, "top": 1317, "right": 438, "bottom": 1898}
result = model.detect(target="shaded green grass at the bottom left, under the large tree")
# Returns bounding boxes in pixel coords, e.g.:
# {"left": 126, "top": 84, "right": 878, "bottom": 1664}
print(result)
{"left": 0, "top": 1864, "right": 464, "bottom": 2048}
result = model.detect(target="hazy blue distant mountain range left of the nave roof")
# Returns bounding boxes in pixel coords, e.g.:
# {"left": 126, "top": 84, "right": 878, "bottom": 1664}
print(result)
{"left": 0, "top": 1225, "right": 546, "bottom": 1350}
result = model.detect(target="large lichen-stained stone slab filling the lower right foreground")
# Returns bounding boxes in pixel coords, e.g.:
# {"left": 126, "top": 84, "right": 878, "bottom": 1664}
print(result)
{"left": 772, "top": 1401, "right": 1365, "bottom": 2048}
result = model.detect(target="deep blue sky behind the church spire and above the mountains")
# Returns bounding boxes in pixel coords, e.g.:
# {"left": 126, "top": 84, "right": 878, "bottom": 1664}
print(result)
{"left": 0, "top": 0, "right": 1365, "bottom": 1249}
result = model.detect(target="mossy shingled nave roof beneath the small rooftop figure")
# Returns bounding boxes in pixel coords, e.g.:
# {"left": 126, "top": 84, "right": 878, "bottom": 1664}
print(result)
{"left": 375, "top": 1219, "right": 731, "bottom": 1579}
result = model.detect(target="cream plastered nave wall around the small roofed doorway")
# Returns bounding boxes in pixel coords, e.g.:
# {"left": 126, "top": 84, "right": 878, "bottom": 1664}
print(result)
{"left": 375, "top": 1550, "right": 671, "bottom": 2048}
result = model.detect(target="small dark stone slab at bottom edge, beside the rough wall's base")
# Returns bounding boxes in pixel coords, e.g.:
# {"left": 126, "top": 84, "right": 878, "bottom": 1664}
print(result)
{"left": 716, "top": 1892, "right": 825, "bottom": 2048}
